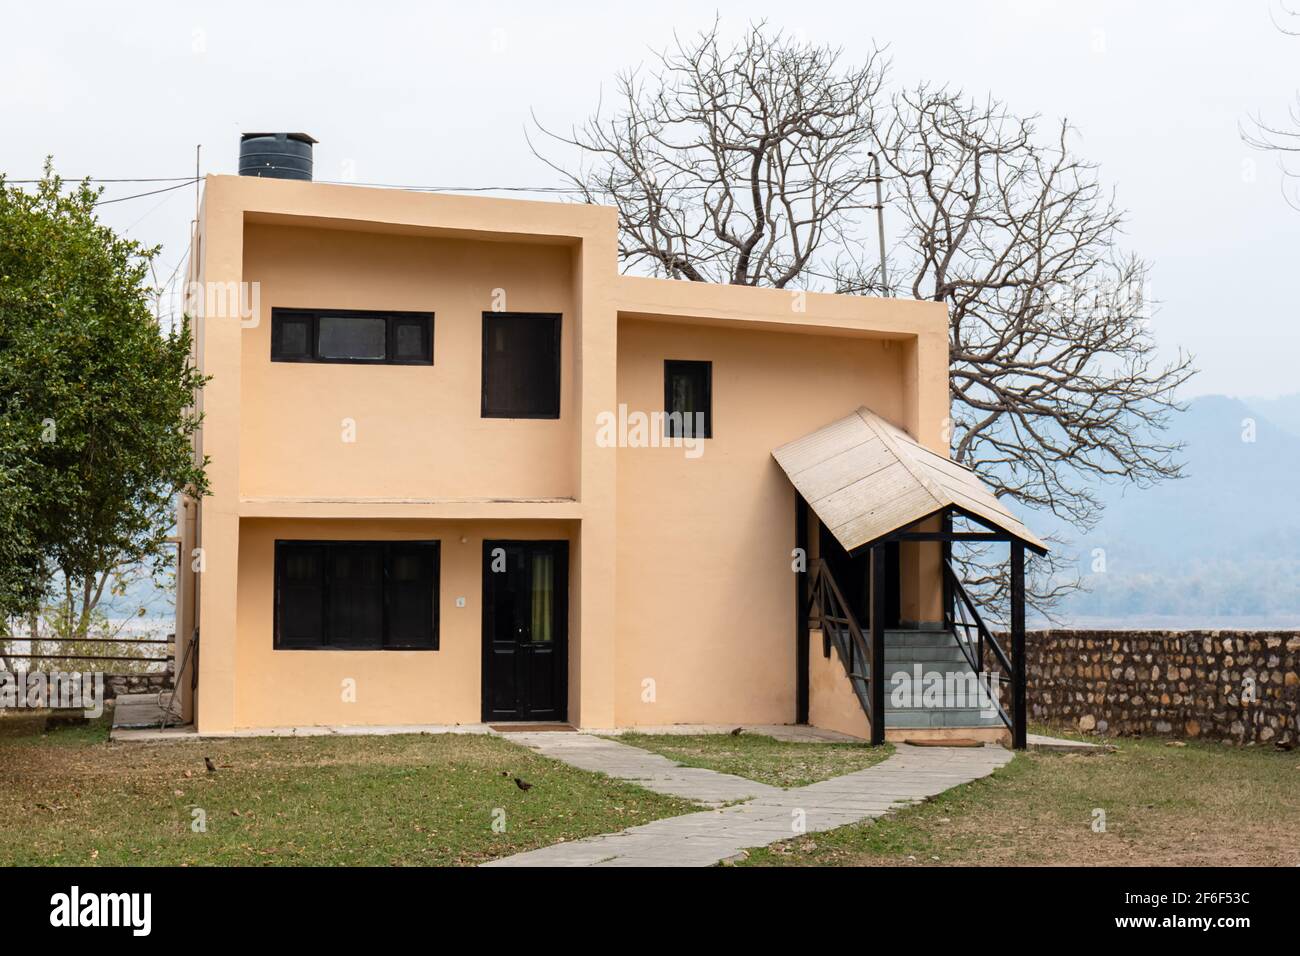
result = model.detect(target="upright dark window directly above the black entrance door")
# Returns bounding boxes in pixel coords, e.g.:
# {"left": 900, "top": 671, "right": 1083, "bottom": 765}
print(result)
{"left": 482, "top": 312, "right": 560, "bottom": 419}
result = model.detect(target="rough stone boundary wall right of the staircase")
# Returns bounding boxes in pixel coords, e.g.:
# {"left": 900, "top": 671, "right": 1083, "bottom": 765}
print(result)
{"left": 1026, "top": 630, "right": 1300, "bottom": 744}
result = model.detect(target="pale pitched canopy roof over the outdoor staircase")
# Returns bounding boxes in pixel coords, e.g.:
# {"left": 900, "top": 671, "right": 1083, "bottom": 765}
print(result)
{"left": 772, "top": 407, "right": 1047, "bottom": 551}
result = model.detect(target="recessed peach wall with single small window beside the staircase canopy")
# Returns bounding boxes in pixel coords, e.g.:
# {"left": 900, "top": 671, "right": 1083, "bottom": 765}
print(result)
{"left": 616, "top": 319, "right": 906, "bottom": 724}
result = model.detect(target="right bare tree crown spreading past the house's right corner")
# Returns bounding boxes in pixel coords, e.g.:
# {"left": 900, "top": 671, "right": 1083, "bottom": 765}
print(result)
{"left": 857, "top": 87, "right": 1191, "bottom": 509}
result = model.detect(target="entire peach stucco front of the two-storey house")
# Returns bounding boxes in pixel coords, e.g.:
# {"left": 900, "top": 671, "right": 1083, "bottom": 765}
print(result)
{"left": 182, "top": 177, "right": 948, "bottom": 732}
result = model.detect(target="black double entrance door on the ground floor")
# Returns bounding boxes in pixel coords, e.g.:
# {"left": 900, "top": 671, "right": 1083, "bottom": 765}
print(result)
{"left": 484, "top": 541, "right": 568, "bottom": 721}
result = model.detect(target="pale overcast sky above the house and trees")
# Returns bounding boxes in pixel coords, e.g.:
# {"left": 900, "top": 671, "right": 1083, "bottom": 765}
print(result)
{"left": 0, "top": 0, "right": 1300, "bottom": 397}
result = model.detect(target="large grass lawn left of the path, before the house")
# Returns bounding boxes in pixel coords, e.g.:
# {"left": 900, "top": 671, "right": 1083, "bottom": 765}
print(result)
{"left": 0, "top": 718, "right": 698, "bottom": 866}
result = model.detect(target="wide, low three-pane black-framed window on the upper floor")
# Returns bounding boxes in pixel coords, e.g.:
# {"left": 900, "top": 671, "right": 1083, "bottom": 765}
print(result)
{"left": 270, "top": 308, "right": 433, "bottom": 365}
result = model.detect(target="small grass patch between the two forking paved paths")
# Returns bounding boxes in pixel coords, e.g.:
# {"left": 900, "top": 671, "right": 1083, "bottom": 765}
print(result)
{"left": 611, "top": 734, "right": 893, "bottom": 787}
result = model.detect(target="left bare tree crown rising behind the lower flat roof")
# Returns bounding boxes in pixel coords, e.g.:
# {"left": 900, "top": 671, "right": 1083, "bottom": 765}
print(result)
{"left": 534, "top": 25, "right": 883, "bottom": 289}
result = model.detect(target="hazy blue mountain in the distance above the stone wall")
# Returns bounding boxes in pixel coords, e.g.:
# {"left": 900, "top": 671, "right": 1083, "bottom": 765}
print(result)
{"left": 1030, "top": 395, "right": 1300, "bottom": 627}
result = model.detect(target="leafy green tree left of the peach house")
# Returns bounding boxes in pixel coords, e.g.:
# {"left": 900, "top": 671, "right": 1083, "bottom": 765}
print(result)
{"left": 0, "top": 161, "right": 207, "bottom": 658}
